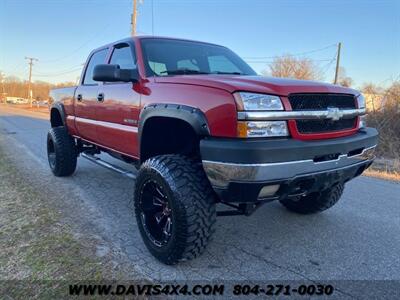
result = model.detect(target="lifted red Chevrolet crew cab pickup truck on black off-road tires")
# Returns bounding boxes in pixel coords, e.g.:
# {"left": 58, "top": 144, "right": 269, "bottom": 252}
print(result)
{"left": 47, "top": 37, "right": 377, "bottom": 264}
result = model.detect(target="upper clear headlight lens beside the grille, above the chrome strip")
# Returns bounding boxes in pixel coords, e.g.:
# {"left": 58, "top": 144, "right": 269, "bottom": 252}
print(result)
{"left": 233, "top": 92, "right": 283, "bottom": 111}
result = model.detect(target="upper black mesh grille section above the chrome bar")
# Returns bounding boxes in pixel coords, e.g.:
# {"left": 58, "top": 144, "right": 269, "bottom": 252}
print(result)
{"left": 289, "top": 94, "right": 356, "bottom": 110}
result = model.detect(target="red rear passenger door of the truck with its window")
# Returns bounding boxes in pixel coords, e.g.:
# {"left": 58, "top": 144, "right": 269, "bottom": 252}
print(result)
{"left": 75, "top": 48, "right": 108, "bottom": 143}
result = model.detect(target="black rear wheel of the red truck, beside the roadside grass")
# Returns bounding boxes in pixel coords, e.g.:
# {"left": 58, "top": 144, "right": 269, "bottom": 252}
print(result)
{"left": 47, "top": 126, "right": 78, "bottom": 177}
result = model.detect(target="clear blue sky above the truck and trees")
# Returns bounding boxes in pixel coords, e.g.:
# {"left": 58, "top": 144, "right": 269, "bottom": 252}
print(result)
{"left": 0, "top": 0, "right": 400, "bottom": 87}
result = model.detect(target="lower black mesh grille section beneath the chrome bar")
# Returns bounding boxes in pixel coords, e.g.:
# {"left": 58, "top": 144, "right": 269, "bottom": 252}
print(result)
{"left": 296, "top": 117, "right": 357, "bottom": 134}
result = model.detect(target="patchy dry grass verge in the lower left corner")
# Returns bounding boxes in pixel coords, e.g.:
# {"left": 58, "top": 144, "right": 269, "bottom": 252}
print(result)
{"left": 0, "top": 145, "right": 123, "bottom": 299}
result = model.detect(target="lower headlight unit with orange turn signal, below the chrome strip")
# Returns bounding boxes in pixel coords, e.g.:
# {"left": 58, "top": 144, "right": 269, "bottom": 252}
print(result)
{"left": 238, "top": 121, "right": 289, "bottom": 138}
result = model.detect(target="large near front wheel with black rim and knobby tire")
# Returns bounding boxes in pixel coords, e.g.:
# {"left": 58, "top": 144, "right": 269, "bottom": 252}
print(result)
{"left": 135, "top": 155, "right": 216, "bottom": 265}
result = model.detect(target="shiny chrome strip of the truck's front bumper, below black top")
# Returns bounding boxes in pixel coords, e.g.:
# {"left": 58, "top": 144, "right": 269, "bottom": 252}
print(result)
{"left": 203, "top": 145, "right": 376, "bottom": 189}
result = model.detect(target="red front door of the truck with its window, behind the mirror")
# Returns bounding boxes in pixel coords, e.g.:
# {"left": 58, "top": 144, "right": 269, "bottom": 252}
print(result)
{"left": 96, "top": 43, "right": 140, "bottom": 157}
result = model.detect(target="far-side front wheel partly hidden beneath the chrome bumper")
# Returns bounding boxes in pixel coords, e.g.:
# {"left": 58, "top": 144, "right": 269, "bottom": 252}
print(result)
{"left": 280, "top": 184, "right": 344, "bottom": 214}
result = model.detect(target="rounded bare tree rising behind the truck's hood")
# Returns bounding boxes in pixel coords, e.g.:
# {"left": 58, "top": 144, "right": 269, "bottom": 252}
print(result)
{"left": 263, "top": 55, "right": 321, "bottom": 80}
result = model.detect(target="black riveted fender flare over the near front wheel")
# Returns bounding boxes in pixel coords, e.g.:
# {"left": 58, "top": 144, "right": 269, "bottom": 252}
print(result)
{"left": 138, "top": 103, "right": 210, "bottom": 156}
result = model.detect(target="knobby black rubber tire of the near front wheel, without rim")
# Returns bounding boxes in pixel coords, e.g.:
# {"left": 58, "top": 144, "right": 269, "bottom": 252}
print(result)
{"left": 135, "top": 154, "right": 216, "bottom": 264}
